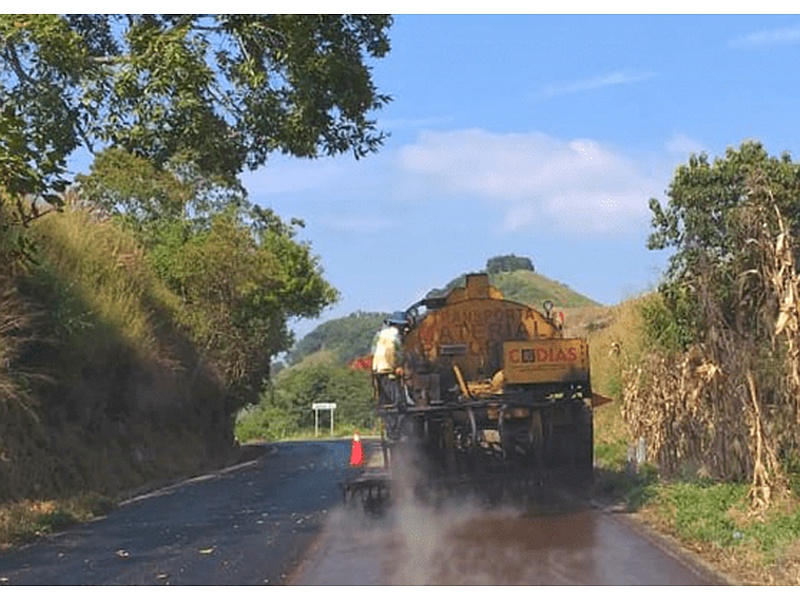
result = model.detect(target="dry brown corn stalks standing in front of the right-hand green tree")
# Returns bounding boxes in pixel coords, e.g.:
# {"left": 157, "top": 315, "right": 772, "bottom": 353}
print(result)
{"left": 623, "top": 174, "right": 800, "bottom": 512}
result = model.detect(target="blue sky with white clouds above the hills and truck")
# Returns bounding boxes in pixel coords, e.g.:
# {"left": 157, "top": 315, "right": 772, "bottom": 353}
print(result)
{"left": 131, "top": 15, "right": 800, "bottom": 336}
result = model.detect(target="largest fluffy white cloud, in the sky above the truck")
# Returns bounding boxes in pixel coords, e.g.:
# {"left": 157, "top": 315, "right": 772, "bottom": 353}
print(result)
{"left": 400, "top": 129, "right": 663, "bottom": 234}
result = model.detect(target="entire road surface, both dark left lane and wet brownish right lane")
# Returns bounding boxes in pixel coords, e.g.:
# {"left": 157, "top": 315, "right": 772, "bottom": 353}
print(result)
{"left": 0, "top": 440, "right": 721, "bottom": 586}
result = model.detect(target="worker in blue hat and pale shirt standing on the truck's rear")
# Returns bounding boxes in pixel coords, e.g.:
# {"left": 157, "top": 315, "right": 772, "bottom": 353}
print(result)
{"left": 372, "top": 313, "right": 408, "bottom": 406}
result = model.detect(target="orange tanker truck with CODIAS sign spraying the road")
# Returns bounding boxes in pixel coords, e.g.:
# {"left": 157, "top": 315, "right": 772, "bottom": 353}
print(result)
{"left": 345, "top": 273, "right": 593, "bottom": 507}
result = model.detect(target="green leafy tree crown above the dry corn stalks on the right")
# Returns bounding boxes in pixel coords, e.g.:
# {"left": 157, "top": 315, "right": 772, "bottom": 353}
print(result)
{"left": 648, "top": 141, "right": 800, "bottom": 347}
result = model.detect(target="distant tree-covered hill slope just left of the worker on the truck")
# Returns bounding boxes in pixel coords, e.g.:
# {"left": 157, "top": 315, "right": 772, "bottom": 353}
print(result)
{"left": 289, "top": 311, "right": 386, "bottom": 365}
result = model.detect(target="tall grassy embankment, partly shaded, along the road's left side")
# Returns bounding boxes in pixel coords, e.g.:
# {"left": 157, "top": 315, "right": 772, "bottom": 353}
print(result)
{"left": 0, "top": 209, "right": 232, "bottom": 547}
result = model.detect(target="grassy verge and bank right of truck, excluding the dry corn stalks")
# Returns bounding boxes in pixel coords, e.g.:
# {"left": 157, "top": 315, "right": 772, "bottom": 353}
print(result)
{"left": 588, "top": 299, "right": 800, "bottom": 585}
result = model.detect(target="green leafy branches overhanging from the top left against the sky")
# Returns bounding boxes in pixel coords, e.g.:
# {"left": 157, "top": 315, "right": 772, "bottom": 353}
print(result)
{"left": 0, "top": 14, "right": 392, "bottom": 204}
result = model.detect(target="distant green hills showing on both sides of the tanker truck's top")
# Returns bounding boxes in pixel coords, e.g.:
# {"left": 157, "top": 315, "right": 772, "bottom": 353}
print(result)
{"left": 288, "top": 254, "right": 600, "bottom": 364}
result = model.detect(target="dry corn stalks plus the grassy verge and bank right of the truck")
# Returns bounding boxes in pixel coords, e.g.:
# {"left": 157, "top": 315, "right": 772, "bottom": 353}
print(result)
{"left": 584, "top": 199, "right": 800, "bottom": 585}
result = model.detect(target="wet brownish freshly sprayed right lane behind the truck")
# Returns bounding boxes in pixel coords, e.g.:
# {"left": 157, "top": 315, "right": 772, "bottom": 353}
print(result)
{"left": 289, "top": 496, "right": 724, "bottom": 586}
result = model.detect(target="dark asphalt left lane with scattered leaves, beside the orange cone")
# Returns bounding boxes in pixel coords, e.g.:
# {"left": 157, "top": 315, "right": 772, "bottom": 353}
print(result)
{"left": 0, "top": 441, "right": 349, "bottom": 585}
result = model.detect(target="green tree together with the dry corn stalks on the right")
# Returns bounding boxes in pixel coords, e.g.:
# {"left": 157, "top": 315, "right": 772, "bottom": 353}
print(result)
{"left": 624, "top": 142, "right": 800, "bottom": 509}
